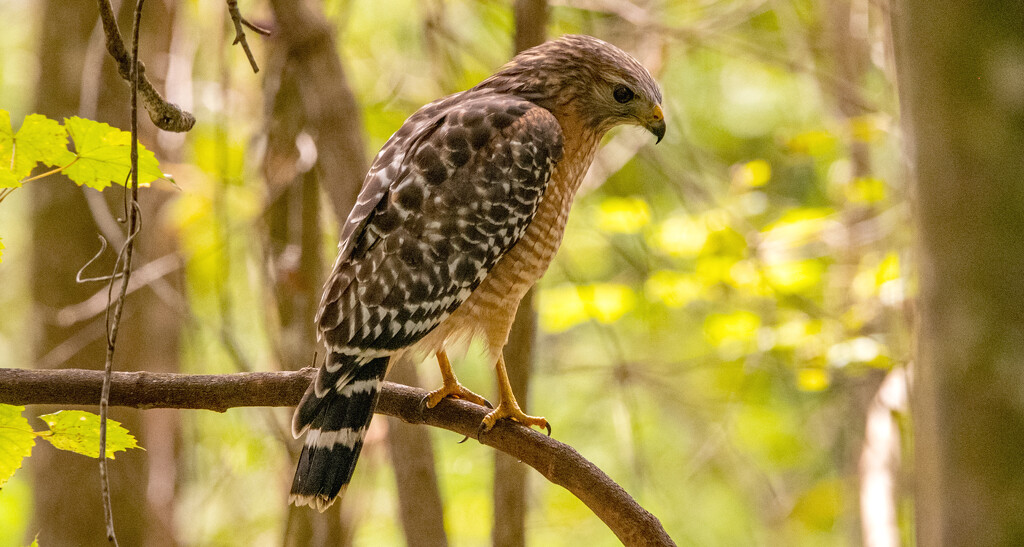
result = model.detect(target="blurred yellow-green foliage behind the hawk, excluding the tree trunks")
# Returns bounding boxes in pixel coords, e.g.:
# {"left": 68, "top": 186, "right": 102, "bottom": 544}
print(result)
{"left": 0, "top": 0, "right": 913, "bottom": 545}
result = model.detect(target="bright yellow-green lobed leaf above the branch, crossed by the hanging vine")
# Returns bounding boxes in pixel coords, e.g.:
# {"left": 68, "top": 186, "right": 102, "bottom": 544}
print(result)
{"left": 63, "top": 116, "right": 166, "bottom": 191}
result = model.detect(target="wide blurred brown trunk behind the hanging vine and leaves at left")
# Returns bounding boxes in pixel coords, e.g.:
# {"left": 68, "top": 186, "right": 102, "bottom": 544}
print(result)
{"left": 28, "top": 0, "right": 180, "bottom": 546}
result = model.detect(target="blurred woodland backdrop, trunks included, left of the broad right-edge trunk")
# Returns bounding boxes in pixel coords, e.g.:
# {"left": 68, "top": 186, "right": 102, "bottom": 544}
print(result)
{"left": 0, "top": 0, "right": 914, "bottom": 546}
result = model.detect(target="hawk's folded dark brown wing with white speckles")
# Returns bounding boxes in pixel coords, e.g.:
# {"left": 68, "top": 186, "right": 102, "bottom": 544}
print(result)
{"left": 316, "top": 91, "right": 562, "bottom": 360}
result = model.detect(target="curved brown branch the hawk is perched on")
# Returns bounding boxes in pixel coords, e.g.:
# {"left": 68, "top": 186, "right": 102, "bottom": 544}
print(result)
{"left": 0, "top": 368, "right": 675, "bottom": 545}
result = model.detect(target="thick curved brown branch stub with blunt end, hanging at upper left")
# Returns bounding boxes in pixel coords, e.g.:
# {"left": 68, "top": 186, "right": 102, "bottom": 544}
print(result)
{"left": 97, "top": 0, "right": 196, "bottom": 133}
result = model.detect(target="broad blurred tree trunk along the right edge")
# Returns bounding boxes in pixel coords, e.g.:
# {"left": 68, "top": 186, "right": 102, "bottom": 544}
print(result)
{"left": 893, "top": 0, "right": 1024, "bottom": 545}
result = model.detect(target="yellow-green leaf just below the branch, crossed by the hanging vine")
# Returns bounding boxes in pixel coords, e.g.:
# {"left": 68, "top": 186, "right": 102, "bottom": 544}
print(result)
{"left": 39, "top": 411, "right": 141, "bottom": 460}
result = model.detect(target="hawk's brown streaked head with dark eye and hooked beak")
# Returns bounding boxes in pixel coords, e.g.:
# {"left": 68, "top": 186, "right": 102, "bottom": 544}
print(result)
{"left": 476, "top": 35, "right": 665, "bottom": 141}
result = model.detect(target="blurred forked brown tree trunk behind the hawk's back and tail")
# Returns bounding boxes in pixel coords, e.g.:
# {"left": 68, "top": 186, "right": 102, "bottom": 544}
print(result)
{"left": 264, "top": 2, "right": 447, "bottom": 546}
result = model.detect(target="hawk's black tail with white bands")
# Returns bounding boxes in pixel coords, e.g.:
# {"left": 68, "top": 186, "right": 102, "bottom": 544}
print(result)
{"left": 289, "top": 353, "right": 390, "bottom": 512}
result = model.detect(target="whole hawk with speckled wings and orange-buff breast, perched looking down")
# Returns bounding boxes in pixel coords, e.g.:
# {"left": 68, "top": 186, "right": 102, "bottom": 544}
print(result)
{"left": 290, "top": 35, "right": 666, "bottom": 511}
